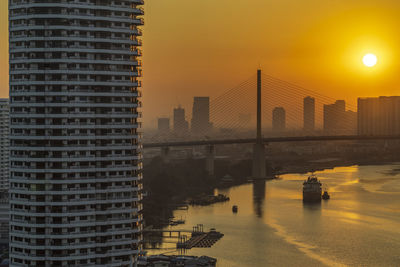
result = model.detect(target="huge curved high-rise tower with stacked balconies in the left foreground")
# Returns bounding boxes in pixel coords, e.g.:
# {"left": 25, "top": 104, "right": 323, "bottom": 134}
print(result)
{"left": 9, "top": 0, "right": 144, "bottom": 266}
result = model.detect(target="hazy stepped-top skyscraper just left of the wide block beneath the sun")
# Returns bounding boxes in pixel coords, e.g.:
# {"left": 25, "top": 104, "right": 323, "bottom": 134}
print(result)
{"left": 324, "top": 100, "right": 348, "bottom": 134}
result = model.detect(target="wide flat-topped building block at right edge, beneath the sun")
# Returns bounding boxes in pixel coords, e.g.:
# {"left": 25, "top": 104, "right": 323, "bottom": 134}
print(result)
{"left": 357, "top": 96, "right": 400, "bottom": 135}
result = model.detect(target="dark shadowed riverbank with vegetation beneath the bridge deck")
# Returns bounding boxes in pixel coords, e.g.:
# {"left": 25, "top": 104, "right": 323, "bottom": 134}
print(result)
{"left": 143, "top": 154, "right": 400, "bottom": 228}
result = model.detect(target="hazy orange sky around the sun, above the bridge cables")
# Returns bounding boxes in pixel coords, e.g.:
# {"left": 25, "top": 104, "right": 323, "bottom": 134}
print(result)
{"left": 0, "top": 0, "right": 400, "bottom": 126}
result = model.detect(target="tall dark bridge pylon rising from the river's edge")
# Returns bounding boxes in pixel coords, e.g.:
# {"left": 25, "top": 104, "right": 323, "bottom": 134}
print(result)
{"left": 252, "top": 69, "right": 266, "bottom": 179}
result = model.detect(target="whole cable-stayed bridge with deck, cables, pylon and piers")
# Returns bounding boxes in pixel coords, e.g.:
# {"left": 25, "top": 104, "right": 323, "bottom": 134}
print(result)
{"left": 143, "top": 70, "right": 400, "bottom": 178}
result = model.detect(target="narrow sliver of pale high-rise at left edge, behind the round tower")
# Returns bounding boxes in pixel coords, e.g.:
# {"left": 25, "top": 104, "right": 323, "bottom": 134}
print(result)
{"left": 0, "top": 98, "right": 10, "bottom": 191}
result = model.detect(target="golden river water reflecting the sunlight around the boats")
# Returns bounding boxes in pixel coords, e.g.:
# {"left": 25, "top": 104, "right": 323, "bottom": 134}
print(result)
{"left": 150, "top": 164, "right": 400, "bottom": 267}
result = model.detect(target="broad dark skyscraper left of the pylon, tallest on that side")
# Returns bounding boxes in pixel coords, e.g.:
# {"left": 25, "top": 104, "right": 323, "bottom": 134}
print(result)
{"left": 191, "top": 97, "right": 212, "bottom": 134}
